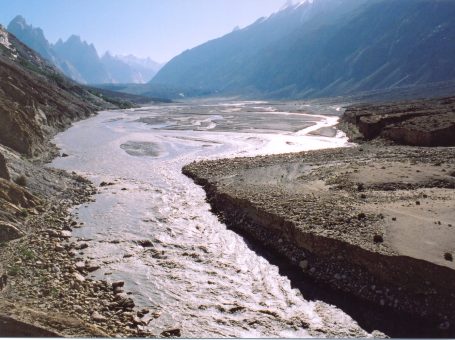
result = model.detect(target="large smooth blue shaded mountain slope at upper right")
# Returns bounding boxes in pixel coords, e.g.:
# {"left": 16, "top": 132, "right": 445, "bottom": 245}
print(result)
{"left": 150, "top": 0, "right": 455, "bottom": 98}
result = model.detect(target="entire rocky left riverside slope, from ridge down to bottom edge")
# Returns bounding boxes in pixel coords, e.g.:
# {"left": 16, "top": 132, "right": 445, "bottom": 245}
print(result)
{"left": 0, "top": 26, "right": 139, "bottom": 337}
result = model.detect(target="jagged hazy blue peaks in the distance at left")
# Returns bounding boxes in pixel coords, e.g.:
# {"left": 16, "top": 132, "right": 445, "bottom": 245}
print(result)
{"left": 7, "top": 16, "right": 161, "bottom": 84}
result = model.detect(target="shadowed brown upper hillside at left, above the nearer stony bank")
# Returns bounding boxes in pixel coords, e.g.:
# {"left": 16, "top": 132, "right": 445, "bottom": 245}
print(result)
{"left": 0, "top": 23, "right": 113, "bottom": 156}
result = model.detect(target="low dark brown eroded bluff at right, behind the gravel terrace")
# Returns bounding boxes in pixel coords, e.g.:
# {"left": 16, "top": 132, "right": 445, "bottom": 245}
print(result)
{"left": 342, "top": 97, "right": 455, "bottom": 146}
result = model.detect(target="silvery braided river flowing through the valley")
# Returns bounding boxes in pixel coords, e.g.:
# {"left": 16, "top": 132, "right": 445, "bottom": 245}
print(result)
{"left": 52, "top": 102, "right": 378, "bottom": 337}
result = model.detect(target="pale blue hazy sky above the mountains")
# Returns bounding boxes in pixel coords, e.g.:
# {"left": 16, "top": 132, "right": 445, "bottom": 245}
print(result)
{"left": 0, "top": 0, "right": 286, "bottom": 62}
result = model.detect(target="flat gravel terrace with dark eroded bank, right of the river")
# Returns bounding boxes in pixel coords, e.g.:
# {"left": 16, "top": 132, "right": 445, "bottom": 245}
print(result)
{"left": 183, "top": 145, "right": 455, "bottom": 335}
